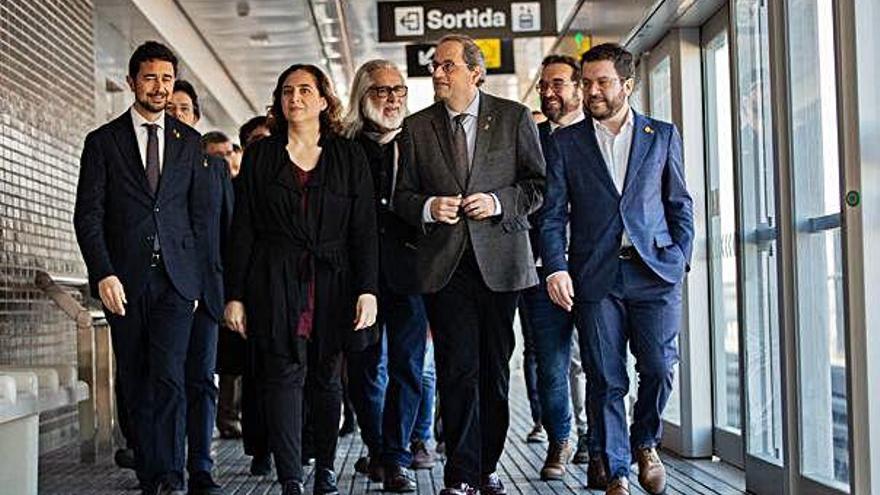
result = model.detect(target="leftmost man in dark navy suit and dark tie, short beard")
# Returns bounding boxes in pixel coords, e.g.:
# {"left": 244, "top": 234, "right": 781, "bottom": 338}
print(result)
{"left": 74, "top": 41, "right": 205, "bottom": 494}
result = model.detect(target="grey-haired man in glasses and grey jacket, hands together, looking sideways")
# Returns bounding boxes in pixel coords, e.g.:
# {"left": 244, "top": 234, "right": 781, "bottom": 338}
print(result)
{"left": 394, "top": 35, "right": 544, "bottom": 495}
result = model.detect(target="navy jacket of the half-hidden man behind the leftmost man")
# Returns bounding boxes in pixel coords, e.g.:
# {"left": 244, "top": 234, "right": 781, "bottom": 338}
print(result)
{"left": 196, "top": 156, "right": 235, "bottom": 322}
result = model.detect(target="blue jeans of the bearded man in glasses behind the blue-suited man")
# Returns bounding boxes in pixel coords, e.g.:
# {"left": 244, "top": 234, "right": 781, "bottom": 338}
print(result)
{"left": 520, "top": 267, "right": 600, "bottom": 454}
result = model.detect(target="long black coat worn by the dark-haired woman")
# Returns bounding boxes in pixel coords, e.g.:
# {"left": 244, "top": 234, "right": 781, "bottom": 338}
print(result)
{"left": 226, "top": 136, "right": 379, "bottom": 358}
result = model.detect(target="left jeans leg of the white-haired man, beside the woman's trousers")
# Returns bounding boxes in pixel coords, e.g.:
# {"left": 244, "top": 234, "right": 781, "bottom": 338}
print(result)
{"left": 346, "top": 333, "right": 388, "bottom": 455}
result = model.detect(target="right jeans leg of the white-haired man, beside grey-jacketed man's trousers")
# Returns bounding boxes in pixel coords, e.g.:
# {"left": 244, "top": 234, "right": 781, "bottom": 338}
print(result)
{"left": 379, "top": 290, "right": 428, "bottom": 467}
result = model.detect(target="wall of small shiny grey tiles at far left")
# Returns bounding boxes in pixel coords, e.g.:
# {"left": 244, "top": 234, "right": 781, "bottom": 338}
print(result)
{"left": 0, "top": 0, "right": 96, "bottom": 451}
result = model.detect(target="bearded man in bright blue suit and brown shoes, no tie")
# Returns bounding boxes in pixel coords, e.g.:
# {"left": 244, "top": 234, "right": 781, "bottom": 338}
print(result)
{"left": 541, "top": 43, "right": 694, "bottom": 495}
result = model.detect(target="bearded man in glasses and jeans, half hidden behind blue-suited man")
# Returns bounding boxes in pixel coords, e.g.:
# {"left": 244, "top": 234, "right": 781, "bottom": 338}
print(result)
{"left": 519, "top": 55, "right": 607, "bottom": 489}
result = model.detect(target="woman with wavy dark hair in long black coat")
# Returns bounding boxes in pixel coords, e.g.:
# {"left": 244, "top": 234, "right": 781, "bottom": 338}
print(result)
{"left": 225, "top": 65, "right": 378, "bottom": 494}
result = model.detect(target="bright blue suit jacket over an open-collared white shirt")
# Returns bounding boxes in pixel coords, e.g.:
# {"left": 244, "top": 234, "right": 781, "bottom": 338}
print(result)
{"left": 541, "top": 111, "right": 694, "bottom": 301}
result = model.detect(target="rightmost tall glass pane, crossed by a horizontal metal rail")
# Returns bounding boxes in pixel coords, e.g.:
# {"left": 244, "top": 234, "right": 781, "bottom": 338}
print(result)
{"left": 787, "top": 0, "right": 849, "bottom": 490}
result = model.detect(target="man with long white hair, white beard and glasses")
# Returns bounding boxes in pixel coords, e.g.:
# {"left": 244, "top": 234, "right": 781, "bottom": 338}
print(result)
{"left": 344, "top": 60, "right": 433, "bottom": 492}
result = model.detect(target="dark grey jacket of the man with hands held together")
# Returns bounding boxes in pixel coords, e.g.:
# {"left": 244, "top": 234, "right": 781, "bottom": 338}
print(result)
{"left": 394, "top": 93, "right": 545, "bottom": 293}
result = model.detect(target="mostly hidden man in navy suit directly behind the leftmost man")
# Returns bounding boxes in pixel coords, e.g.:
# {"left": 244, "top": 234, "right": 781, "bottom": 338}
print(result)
{"left": 166, "top": 83, "right": 233, "bottom": 495}
